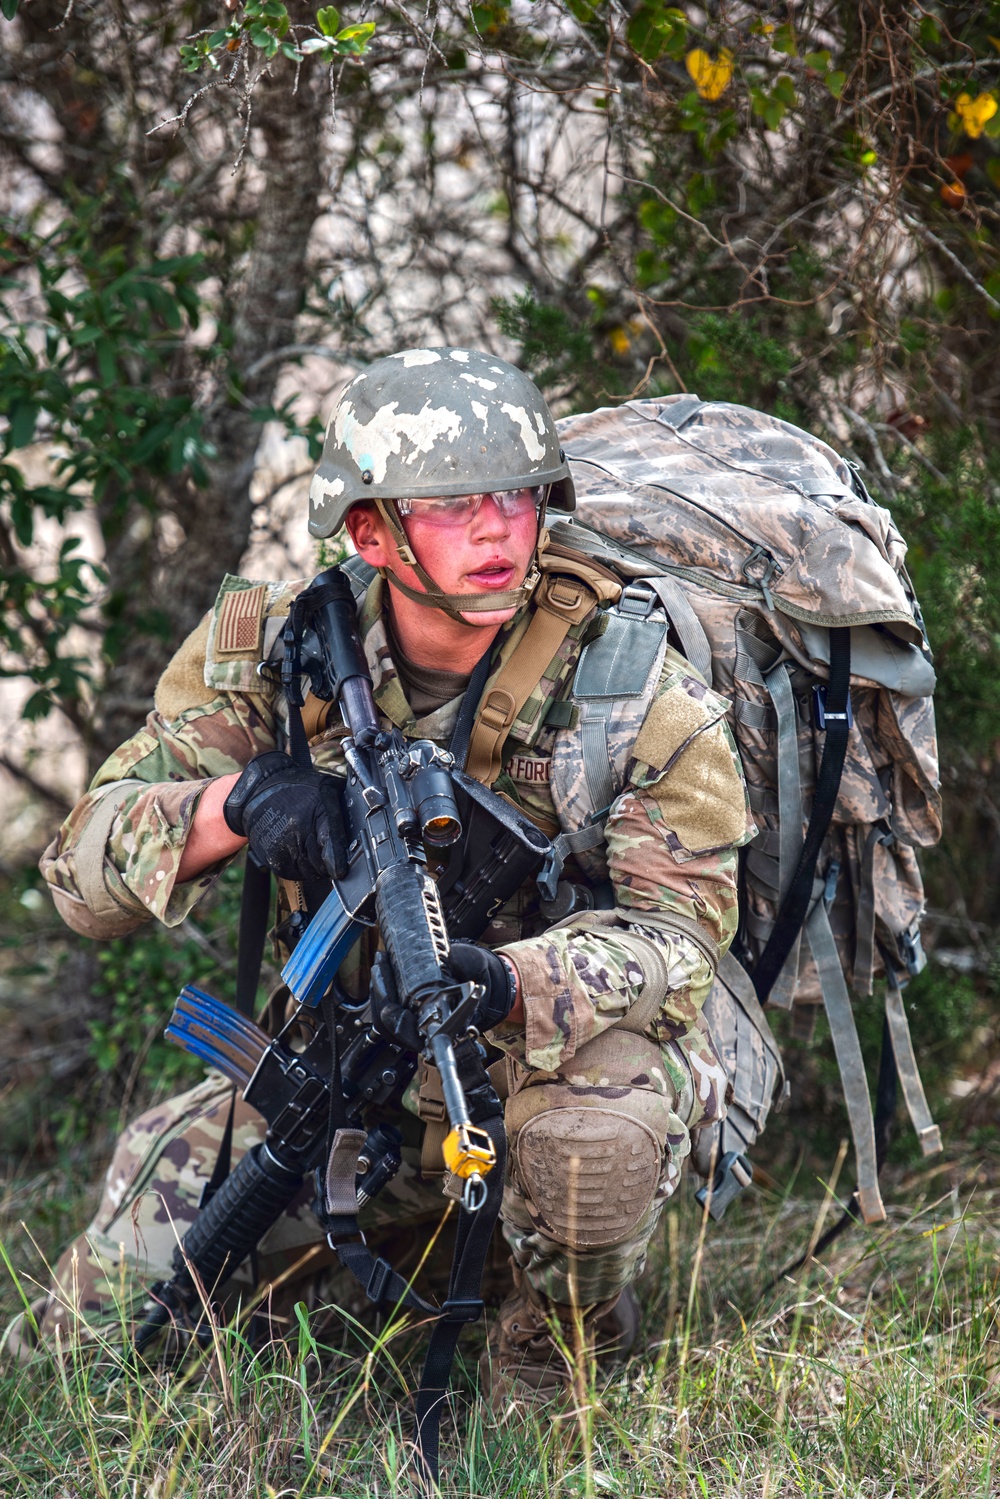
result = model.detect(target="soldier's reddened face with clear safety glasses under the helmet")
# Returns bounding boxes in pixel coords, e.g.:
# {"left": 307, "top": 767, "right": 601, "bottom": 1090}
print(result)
{"left": 348, "top": 495, "right": 538, "bottom": 627}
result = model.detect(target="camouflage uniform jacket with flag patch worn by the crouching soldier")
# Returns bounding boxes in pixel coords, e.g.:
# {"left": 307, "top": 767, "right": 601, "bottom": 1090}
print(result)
{"left": 42, "top": 563, "right": 756, "bottom": 1091}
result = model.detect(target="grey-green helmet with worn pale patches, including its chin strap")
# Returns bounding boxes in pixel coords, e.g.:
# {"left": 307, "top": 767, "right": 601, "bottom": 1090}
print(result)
{"left": 309, "top": 349, "right": 576, "bottom": 618}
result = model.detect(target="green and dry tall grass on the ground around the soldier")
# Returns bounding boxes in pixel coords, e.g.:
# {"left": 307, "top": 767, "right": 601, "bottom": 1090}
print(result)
{"left": 0, "top": 1157, "right": 1000, "bottom": 1499}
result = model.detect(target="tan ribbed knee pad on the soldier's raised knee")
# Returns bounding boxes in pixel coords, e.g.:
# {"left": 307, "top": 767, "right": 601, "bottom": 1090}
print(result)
{"left": 505, "top": 1031, "right": 676, "bottom": 1250}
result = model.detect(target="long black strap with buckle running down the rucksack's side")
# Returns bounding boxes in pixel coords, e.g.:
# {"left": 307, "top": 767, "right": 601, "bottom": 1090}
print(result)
{"left": 751, "top": 627, "right": 850, "bottom": 1004}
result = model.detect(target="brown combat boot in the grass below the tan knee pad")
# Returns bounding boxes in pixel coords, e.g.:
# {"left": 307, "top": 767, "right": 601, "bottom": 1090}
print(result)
{"left": 480, "top": 1268, "right": 639, "bottom": 1418}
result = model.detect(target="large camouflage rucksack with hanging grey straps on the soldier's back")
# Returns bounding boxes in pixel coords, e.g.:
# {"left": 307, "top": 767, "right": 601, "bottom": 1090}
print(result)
{"left": 552, "top": 396, "right": 942, "bottom": 1222}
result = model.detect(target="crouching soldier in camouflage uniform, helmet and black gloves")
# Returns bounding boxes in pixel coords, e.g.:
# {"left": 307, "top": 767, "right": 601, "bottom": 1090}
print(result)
{"left": 9, "top": 349, "right": 754, "bottom": 1411}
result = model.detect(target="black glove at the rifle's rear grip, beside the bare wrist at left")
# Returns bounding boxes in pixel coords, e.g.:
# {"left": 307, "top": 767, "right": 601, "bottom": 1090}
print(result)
{"left": 222, "top": 750, "right": 348, "bottom": 880}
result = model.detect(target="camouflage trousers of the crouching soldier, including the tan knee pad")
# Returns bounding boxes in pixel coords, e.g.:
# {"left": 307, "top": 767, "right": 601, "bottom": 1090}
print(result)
{"left": 17, "top": 1028, "right": 718, "bottom": 1340}
